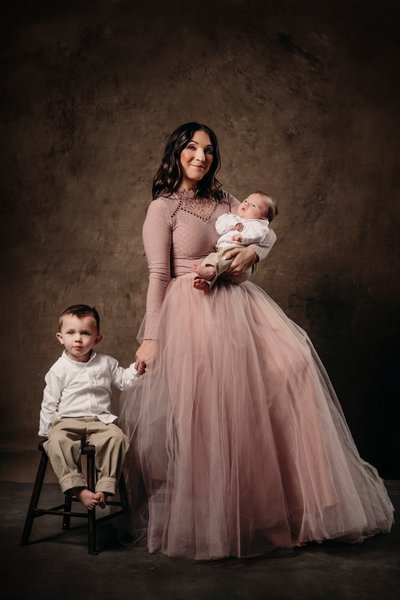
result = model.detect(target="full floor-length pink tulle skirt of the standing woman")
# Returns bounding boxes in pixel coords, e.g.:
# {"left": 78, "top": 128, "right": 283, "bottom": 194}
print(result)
{"left": 120, "top": 275, "right": 393, "bottom": 559}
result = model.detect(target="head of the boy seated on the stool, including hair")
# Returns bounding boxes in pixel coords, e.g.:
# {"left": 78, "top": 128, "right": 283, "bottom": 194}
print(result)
{"left": 56, "top": 304, "right": 101, "bottom": 362}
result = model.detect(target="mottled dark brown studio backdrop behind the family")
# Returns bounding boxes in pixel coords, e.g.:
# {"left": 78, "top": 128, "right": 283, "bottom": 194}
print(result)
{"left": 0, "top": 0, "right": 400, "bottom": 481}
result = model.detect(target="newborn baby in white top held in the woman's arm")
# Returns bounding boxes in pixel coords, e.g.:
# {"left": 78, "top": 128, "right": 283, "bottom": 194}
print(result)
{"left": 193, "top": 192, "right": 278, "bottom": 292}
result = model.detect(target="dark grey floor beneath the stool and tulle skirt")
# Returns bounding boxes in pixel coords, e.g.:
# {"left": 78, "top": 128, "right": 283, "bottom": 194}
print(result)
{"left": 0, "top": 481, "right": 400, "bottom": 600}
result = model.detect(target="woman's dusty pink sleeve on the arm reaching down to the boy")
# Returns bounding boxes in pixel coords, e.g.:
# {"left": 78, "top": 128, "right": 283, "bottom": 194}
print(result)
{"left": 143, "top": 198, "right": 172, "bottom": 340}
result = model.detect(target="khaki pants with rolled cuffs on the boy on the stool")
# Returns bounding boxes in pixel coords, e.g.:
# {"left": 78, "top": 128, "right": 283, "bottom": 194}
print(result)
{"left": 43, "top": 417, "right": 129, "bottom": 494}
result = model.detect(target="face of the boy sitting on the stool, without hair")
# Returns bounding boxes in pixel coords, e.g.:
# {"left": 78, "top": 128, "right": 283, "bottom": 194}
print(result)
{"left": 56, "top": 315, "right": 101, "bottom": 362}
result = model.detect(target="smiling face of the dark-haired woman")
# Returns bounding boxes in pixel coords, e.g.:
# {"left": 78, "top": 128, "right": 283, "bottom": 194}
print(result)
{"left": 180, "top": 131, "right": 214, "bottom": 190}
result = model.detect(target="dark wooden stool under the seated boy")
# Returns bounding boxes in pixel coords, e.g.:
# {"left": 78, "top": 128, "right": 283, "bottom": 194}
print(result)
{"left": 21, "top": 443, "right": 129, "bottom": 554}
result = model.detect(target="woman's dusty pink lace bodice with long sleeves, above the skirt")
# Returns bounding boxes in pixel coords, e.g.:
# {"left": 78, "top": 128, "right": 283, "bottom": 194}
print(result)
{"left": 143, "top": 192, "right": 276, "bottom": 339}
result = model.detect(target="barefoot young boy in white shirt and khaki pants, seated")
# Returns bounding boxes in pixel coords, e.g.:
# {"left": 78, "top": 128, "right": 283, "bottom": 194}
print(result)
{"left": 39, "top": 304, "right": 144, "bottom": 510}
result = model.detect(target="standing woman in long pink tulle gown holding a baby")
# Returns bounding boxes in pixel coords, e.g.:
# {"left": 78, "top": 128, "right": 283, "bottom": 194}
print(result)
{"left": 121, "top": 123, "right": 393, "bottom": 559}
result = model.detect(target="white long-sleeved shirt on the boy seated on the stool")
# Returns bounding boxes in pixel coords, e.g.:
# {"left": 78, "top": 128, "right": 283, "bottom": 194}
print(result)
{"left": 39, "top": 351, "right": 141, "bottom": 437}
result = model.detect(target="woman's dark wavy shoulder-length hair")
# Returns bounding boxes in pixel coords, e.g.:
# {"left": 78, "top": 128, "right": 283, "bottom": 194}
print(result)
{"left": 152, "top": 122, "right": 222, "bottom": 200}
